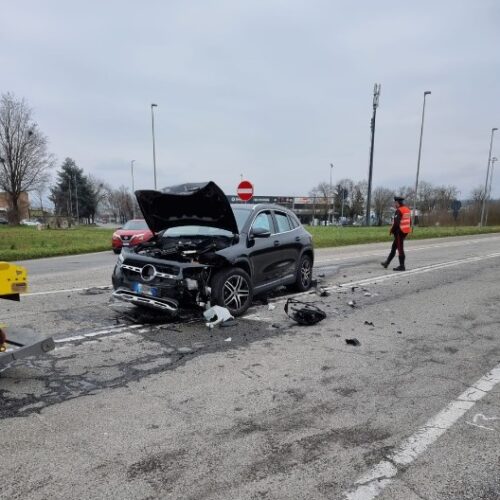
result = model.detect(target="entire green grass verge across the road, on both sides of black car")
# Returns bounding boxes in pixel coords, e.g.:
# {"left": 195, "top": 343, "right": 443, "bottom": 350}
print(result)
{"left": 0, "top": 226, "right": 500, "bottom": 261}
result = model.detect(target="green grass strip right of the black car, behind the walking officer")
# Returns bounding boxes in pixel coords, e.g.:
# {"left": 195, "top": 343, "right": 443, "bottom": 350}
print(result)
{"left": 306, "top": 226, "right": 500, "bottom": 248}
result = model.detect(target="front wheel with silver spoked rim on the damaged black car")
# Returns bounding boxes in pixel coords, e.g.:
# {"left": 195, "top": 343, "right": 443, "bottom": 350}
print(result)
{"left": 211, "top": 267, "right": 253, "bottom": 316}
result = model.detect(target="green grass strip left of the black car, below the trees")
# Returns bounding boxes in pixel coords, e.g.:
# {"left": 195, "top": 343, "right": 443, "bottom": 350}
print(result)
{"left": 0, "top": 226, "right": 113, "bottom": 261}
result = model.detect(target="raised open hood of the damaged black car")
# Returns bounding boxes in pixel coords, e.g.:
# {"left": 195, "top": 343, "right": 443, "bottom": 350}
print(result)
{"left": 135, "top": 181, "right": 238, "bottom": 234}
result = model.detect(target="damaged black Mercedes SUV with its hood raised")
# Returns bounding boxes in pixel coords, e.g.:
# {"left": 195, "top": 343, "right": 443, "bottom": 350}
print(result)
{"left": 112, "top": 182, "right": 314, "bottom": 316}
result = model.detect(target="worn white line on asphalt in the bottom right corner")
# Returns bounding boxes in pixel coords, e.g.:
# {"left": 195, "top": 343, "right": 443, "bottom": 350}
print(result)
{"left": 345, "top": 365, "right": 500, "bottom": 500}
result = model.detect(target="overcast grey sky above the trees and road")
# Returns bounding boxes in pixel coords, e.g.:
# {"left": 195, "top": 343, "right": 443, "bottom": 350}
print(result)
{"left": 0, "top": 0, "right": 500, "bottom": 198}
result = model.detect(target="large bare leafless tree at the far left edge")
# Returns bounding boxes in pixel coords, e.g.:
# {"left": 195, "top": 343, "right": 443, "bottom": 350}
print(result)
{"left": 0, "top": 93, "right": 54, "bottom": 224}
